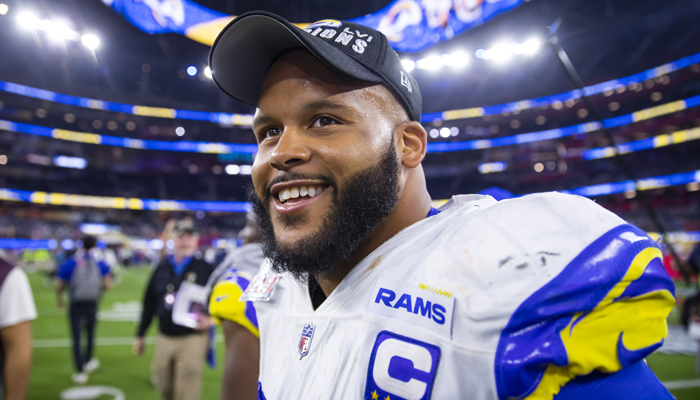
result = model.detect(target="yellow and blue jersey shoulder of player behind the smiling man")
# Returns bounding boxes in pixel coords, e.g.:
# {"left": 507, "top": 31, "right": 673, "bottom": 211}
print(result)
{"left": 209, "top": 267, "right": 260, "bottom": 337}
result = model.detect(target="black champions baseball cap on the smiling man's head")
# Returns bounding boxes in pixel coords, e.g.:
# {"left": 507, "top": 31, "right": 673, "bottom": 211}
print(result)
{"left": 209, "top": 11, "right": 422, "bottom": 122}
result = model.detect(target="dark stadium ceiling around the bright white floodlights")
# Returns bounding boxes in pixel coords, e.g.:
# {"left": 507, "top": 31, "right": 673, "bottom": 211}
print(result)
{"left": 0, "top": 0, "right": 700, "bottom": 113}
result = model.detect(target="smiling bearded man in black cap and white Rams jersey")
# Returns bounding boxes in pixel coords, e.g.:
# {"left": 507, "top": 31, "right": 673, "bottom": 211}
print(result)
{"left": 210, "top": 12, "right": 675, "bottom": 400}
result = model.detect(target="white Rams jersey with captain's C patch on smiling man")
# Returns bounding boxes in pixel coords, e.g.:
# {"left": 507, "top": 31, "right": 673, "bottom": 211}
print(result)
{"left": 251, "top": 193, "right": 675, "bottom": 400}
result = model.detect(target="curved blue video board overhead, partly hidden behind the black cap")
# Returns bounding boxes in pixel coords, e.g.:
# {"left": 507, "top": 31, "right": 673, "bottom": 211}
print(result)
{"left": 102, "top": 0, "right": 526, "bottom": 52}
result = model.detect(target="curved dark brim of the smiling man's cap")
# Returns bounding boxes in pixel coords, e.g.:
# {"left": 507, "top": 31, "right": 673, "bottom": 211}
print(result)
{"left": 209, "top": 11, "right": 383, "bottom": 106}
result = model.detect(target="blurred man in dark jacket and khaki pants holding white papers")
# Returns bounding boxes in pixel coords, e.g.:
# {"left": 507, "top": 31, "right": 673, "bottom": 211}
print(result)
{"left": 133, "top": 220, "right": 214, "bottom": 400}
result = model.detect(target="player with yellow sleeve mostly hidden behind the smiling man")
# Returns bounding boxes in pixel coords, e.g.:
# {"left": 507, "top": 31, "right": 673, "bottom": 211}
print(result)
{"left": 207, "top": 211, "right": 265, "bottom": 400}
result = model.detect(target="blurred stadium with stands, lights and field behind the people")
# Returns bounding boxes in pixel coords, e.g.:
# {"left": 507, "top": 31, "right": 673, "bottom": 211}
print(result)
{"left": 0, "top": 0, "right": 700, "bottom": 399}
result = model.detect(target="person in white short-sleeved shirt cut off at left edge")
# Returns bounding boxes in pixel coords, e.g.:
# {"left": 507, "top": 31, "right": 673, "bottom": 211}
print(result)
{"left": 0, "top": 258, "right": 37, "bottom": 400}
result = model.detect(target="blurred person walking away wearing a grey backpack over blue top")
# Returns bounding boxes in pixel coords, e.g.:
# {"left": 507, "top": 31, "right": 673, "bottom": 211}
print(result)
{"left": 56, "top": 236, "right": 112, "bottom": 385}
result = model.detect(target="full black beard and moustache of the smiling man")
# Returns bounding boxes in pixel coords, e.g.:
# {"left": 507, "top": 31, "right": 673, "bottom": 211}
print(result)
{"left": 248, "top": 137, "right": 399, "bottom": 282}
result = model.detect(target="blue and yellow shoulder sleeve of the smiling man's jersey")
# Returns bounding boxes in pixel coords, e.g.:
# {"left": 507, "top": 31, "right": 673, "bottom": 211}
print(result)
{"left": 495, "top": 205, "right": 675, "bottom": 399}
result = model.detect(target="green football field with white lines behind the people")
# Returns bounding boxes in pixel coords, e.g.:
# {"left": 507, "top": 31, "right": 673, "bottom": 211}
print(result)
{"left": 27, "top": 268, "right": 700, "bottom": 400}
